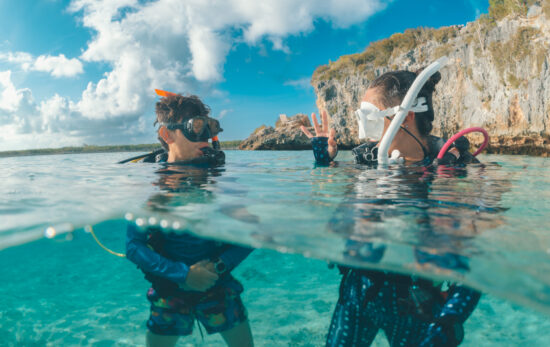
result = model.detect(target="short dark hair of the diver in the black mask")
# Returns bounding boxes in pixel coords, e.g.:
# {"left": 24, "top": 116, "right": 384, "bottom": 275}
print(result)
{"left": 155, "top": 94, "right": 210, "bottom": 150}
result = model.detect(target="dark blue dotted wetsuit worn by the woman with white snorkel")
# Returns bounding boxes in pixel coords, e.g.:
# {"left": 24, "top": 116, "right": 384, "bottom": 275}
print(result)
{"left": 312, "top": 136, "right": 481, "bottom": 347}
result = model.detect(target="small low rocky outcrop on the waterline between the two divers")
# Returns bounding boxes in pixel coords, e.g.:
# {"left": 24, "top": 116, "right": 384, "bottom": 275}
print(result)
{"left": 239, "top": 114, "right": 311, "bottom": 150}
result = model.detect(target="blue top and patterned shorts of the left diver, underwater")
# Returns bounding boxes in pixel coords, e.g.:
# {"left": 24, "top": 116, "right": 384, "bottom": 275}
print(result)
{"left": 126, "top": 220, "right": 252, "bottom": 336}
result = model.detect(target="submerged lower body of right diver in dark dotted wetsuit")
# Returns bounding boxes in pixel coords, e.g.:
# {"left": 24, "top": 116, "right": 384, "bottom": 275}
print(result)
{"left": 327, "top": 268, "right": 480, "bottom": 347}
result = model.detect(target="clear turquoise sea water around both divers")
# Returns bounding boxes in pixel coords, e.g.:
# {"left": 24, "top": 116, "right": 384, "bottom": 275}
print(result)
{"left": 0, "top": 151, "right": 550, "bottom": 346}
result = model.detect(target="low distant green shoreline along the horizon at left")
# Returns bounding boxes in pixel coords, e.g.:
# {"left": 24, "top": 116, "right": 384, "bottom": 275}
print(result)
{"left": 0, "top": 140, "right": 241, "bottom": 158}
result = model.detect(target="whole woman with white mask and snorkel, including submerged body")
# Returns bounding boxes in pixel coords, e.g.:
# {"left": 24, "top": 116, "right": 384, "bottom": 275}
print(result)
{"left": 302, "top": 58, "right": 492, "bottom": 347}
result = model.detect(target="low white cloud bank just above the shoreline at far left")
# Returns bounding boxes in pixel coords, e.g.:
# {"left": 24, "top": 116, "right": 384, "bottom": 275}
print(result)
{"left": 0, "top": 71, "right": 154, "bottom": 150}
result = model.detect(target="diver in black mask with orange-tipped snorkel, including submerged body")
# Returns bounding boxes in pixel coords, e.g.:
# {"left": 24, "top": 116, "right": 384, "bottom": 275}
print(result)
{"left": 126, "top": 91, "right": 253, "bottom": 347}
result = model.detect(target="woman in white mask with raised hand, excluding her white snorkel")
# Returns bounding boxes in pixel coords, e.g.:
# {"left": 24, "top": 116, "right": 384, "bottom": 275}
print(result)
{"left": 302, "top": 61, "right": 481, "bottom": 347}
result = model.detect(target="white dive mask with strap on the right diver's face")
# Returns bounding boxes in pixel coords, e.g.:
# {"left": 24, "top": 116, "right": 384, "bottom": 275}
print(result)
{"left": 355, "top": 97, "right": 428, "bottom": 141}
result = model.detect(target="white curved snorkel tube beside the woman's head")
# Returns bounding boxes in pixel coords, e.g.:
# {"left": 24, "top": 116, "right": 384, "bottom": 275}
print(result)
{"left": 378, "top": 57, "right": 449, "bottom": 165}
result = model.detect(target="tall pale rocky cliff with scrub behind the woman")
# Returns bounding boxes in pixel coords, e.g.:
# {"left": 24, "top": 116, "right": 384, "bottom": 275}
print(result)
{"left": 311, "top": 0, "right": 550, "bottom": 156}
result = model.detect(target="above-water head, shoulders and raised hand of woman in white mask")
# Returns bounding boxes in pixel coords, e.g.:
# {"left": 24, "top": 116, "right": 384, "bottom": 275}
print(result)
{"left": 302, "top": 58, "right": 477, "bottom": 169}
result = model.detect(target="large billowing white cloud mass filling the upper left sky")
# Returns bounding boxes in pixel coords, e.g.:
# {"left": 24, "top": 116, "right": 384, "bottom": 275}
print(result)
{"left": 0, "top": 0, "right": 384, "bottom": 150}
